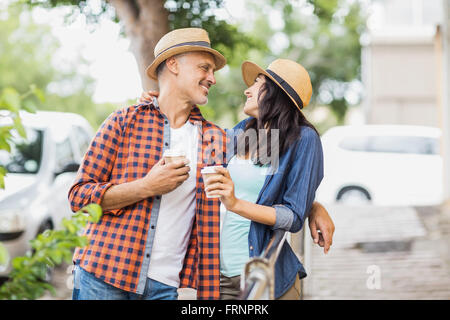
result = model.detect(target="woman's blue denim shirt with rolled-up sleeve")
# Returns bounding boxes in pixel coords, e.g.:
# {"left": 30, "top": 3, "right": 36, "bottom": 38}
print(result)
{"left": 227, "top": 118, "right": 323, "bottom": 298}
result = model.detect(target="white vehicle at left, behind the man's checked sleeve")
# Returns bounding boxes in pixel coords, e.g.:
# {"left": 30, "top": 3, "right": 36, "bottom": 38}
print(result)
{"left": 0, "top": 111, "right": 93, "bottom": 276}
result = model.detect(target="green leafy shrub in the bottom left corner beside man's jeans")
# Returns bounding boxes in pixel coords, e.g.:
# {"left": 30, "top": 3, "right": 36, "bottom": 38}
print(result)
{"left": 0, "top": 204, "right": 102, "bottom": 300}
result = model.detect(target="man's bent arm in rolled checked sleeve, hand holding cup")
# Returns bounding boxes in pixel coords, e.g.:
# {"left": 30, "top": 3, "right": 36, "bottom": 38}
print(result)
{"left": 69, "top": 110, "right": 189, "bottom": 215}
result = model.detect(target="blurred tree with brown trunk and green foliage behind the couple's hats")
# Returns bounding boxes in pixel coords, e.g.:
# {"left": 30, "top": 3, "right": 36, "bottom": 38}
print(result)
{"left": 15, "top": 0, "right": 366, "bottom": 124}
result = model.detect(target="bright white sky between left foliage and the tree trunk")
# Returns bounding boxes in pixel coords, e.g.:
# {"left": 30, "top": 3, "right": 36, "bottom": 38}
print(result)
{"left": 32, "top": 0, "right": 245, "bottom": 103}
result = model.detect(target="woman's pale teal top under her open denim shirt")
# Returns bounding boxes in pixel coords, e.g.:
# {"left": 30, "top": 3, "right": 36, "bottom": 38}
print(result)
{"left": 220, "top": 157, "right": 268, "bottom": 277}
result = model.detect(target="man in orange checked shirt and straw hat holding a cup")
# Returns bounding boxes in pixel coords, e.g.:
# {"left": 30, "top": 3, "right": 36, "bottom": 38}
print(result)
{"left": 69, "top": 28, "right": 331, "bottom": 299}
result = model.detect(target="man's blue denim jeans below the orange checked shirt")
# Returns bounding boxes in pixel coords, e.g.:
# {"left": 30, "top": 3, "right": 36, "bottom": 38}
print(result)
{"left": 72, "top": 265, "right": 178, "bottom": 300}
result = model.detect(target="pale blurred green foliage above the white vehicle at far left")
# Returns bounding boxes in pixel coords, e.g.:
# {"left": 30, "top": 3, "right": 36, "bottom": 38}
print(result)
{"left": 0, "top": 5, "right": 117, "bottom": 128}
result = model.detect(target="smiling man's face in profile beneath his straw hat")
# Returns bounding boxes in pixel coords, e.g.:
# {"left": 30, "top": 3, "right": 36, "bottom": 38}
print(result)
{"left": 177, "top": 52, "right": 216, "bottom": 105}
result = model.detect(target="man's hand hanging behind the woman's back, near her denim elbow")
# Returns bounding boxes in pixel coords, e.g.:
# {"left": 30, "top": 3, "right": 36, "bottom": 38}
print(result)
{"left": 308, "top": 202, "right": 334, "bottom": 254}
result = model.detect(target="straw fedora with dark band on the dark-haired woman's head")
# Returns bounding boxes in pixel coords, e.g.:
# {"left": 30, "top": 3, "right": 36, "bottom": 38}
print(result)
{"left": 242, "top": 59, "right": 312, "bottom": 110}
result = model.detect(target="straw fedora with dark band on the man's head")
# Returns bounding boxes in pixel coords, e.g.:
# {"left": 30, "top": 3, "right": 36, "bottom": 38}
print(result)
{"left": 146, "top": 28, "right": 227, "bottom": 80}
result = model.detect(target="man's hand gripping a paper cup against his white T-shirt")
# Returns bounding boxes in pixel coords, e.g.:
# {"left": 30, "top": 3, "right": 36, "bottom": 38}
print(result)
{"left": 141, "top": 158, "right": 190, "bottom": 197}
